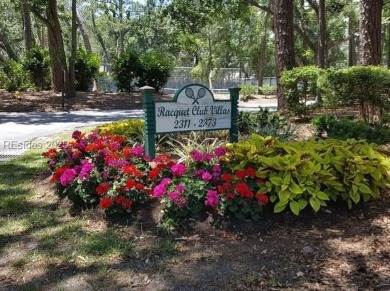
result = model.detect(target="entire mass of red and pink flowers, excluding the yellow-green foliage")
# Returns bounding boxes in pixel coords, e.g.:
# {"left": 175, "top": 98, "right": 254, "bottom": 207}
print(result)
{"left": 43, "top": 131, "right": 269, "bottom": 220}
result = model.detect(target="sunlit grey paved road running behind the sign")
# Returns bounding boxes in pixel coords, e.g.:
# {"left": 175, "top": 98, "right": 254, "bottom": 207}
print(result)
{"left": 0, "top": 103, "right": 276, "bottom": 161}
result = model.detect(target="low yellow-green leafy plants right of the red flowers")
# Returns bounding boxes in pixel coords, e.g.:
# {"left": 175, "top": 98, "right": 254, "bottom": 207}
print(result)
{"left": 228, "top": 135, "right": 390, "bottom": 215}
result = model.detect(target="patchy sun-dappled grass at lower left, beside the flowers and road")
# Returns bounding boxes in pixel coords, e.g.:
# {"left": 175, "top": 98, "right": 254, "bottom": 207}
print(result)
{"left": 0, "top": 133, "right": 175, "bottom": 290}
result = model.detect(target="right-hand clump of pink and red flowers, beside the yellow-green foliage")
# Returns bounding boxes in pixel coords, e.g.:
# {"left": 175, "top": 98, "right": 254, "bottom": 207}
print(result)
{"left": 152, "top": 147, "right": 269, "bottom": 220}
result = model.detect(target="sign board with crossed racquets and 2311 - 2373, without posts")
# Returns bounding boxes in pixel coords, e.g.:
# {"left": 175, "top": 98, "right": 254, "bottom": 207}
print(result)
{"left": 155, "top": 85, "right": 232, "bottom": 133}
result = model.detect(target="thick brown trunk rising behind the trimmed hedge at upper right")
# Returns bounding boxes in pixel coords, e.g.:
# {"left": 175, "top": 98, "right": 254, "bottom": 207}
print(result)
{"left": 360, "top": 0, "right": 383, "bottom": 65}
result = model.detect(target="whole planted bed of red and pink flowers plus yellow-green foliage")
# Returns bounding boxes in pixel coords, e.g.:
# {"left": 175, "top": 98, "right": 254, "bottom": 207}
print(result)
{"left": 43, "top": 131, "right": 390, "bottom": 220}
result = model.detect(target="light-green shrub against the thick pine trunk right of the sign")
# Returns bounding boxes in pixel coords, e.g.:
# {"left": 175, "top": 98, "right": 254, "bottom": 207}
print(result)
{"left": 280, "top": 66, "right": 326, "bottom": 117}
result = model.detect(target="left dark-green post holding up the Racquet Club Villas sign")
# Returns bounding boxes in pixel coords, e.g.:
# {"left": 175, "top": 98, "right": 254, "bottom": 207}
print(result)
{"left": 140, "top": 86, "right": 156, "bottom": 159}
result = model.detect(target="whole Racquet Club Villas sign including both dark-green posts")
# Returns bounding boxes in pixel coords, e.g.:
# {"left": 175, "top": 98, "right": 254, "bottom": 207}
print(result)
{"left": 141, "top": 84, "right": 240, "bottom": 158}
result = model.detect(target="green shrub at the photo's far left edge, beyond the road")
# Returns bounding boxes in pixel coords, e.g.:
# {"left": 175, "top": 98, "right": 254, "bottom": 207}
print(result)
{"left": 0, "top": 60, "right": 32, "bottom": 91}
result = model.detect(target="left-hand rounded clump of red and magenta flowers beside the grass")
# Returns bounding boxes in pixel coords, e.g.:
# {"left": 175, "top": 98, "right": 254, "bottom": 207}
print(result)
{"left": 43, "top": 131, "right": 155, "bottom": 212}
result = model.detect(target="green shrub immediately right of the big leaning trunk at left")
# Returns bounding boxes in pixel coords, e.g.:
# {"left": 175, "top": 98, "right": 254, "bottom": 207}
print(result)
{"left": 75, "top": 49, "right": 100, "bottom": 91}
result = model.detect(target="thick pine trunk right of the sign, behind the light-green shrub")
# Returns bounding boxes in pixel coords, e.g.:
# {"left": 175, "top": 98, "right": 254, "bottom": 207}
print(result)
{"left": 274, "top": 0, "right": 295, "bottom": 112}
